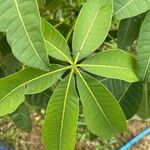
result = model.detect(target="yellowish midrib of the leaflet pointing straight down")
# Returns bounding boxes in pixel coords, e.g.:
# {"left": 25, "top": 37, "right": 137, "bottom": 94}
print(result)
{"left": 58, "top": 69, "right": 74, "bottom": 150}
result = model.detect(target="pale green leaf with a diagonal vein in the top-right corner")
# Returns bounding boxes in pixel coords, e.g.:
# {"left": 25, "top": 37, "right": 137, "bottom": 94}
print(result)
{"left": 114, "top": 0, "right": 150, "bottom": 20}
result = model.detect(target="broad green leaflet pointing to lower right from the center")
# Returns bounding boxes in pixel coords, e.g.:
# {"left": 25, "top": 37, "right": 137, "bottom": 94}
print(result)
{"left": 77, "top": 72, "right": 126, "bottom": 138}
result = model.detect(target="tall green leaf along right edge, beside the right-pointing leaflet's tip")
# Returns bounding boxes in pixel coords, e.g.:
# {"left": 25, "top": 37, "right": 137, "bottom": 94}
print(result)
{"left": 137, "top": 12, "right": 150, "bottom": 82}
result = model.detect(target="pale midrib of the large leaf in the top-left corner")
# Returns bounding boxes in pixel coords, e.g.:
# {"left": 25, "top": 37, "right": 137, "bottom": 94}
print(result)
{"left": 14, "top": 0, "right": 47, "bottom": 68}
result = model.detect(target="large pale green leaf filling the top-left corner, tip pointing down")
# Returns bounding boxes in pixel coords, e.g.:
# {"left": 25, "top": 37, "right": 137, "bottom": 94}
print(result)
{"left": 0, "top": 0, "right": 49, "bottom": 70}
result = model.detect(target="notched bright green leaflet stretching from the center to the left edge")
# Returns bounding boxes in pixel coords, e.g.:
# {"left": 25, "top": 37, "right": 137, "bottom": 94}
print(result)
{"left": 0, "top": 65, "right": 67, "bottom": 117}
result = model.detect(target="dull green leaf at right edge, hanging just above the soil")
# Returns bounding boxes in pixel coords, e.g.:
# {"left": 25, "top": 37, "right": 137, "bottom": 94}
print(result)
{"left": 137, "top": 84, "right": 150, "bottom": 119}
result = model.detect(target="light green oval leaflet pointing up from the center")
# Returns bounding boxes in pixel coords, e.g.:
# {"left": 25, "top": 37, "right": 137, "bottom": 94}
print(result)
{"left": 72, "top": 0, "right": 113, "bottom": 62}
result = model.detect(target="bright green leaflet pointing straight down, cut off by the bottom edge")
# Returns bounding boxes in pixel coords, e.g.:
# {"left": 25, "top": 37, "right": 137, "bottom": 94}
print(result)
{"left": 43, "top": 72, "right": 79, "bottom": 150}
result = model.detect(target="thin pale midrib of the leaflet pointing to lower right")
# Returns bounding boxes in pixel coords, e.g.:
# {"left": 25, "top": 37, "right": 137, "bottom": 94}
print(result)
{"left": 77, "top": 69, "right": 117, "bottom": 131}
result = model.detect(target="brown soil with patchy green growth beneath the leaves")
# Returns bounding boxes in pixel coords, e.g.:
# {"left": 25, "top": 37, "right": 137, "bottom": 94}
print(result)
{"left": 0, "top": 113, "right": 150, "bottom": 150}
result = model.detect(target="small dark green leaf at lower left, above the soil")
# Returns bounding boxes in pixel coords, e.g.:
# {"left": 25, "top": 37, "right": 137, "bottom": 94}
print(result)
{"left": 10, "top": 103, "right": 32, "bottom": 133}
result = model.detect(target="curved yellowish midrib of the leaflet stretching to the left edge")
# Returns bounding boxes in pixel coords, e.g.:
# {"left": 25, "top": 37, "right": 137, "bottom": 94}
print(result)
{"left": 0, "top": 66, "right": 70, "bottom": 102}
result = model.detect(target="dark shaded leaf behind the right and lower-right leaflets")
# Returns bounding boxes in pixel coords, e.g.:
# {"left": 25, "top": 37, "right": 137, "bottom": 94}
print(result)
{"left": 101, "top": 78, "right": 143, "bottom": 119}
